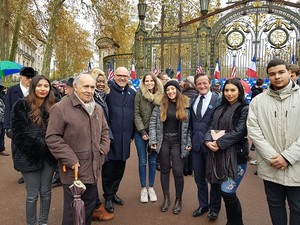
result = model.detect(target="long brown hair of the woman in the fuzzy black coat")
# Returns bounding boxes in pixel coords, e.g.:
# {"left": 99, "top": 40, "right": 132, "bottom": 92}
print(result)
{"left": 26, "top": 75, "right": 55, "bottom": 125}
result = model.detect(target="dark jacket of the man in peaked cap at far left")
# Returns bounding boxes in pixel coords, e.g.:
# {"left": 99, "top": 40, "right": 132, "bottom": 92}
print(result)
{"left": 3, "top": 84, "right": 24, "bottom": 129}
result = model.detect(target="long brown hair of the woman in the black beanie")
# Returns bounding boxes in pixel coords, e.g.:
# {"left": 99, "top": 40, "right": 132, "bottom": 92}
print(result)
{"left": 160, "top": 89, "right": 189, "bottom": 122}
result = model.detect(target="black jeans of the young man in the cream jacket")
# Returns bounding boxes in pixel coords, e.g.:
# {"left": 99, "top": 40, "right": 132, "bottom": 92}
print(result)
{"left": 264, "top": 180, "right": 300, "bottom": 225}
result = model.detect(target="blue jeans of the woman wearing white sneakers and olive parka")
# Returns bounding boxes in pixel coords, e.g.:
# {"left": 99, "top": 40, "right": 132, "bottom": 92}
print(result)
{"left": 134, "top": 133, "right": 157, "bottom": 187}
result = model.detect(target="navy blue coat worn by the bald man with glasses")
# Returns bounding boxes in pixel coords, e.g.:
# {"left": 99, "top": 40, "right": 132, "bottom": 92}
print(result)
{"left": 106, "top": 81, "right": 136, "bottom": 161}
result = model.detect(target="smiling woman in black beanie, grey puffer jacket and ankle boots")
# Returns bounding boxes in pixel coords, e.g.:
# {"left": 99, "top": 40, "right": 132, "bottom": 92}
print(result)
{"left": 149, "top": 80, "right": 191, "bottom": 214}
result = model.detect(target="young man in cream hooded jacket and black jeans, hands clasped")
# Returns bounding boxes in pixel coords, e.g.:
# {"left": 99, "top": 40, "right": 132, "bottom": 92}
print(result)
{"left": 247, "top": 59, "right": 300, "bottom": 225}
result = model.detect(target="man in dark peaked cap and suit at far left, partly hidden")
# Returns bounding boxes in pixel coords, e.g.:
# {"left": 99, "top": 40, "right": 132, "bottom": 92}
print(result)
{"left": 3, "top": 67, "right": 35, "bottom": 184}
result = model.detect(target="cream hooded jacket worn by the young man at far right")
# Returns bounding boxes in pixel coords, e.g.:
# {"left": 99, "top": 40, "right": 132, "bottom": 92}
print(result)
{"left": 247, "top": 81, "right": 300, "bottom": 187}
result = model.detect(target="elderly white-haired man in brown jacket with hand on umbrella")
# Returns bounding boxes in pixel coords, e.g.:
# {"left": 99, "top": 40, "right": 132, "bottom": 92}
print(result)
{"left": 46, "top": 74, "right": 110, "bottom": 225}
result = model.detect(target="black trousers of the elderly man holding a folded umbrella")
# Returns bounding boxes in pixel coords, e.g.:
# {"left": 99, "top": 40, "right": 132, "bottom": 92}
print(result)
{"left": 62, "top": 184, "right": 98, "bottom": 225}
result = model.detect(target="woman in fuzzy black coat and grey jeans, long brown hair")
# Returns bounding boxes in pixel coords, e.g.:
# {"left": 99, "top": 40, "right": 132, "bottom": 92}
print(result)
{"left": 11, "top": 75, "right": 57, "bottom": 225}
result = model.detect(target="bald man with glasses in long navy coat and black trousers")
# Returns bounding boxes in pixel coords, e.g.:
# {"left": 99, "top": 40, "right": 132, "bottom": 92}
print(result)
{"left": 102, "top": 67, "right": 135, "bottom": 213}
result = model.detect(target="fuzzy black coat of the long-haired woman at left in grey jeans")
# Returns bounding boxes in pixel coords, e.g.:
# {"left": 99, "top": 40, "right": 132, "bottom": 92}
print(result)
{"left": 11, "top": 98, "right": 57, "bottom": 172}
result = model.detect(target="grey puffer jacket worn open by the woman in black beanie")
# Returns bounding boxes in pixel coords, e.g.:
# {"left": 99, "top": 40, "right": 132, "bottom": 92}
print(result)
{"left": 149, "top": 97, "right": 192, "bottom": 153}
